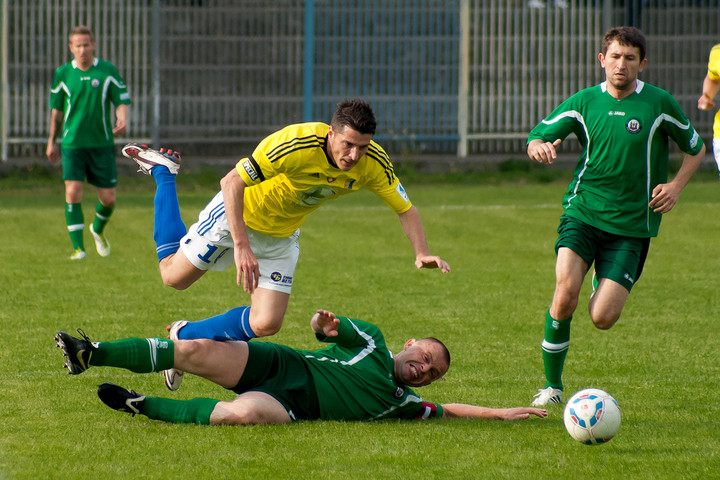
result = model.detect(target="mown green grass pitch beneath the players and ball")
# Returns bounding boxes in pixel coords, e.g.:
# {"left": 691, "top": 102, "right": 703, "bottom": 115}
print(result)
{"left": 0, "top": 171, "right": 720, "bottom": 480}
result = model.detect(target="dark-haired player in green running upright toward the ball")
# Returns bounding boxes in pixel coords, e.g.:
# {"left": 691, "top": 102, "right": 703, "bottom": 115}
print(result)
{"left": 527, "top": 27, "right": 705, "bottom": 405}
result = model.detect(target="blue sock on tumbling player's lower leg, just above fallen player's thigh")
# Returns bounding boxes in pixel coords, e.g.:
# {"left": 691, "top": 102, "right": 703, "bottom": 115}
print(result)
{"left": 178, "top": 307, "right": 257, "bottom": 342}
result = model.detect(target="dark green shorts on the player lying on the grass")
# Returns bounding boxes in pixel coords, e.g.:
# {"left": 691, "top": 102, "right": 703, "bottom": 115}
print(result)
{"left": 231, "top": 342, "right": 320, "bottom": 420}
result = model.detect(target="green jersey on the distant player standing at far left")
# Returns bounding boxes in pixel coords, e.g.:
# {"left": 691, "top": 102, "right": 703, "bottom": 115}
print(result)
{"left": 50, "top": 58, "right": 130, "bottom": 148}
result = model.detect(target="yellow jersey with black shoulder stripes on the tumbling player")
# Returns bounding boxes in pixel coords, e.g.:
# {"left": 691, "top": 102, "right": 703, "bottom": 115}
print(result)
{"left": 235, "top": 122, "right": 412, "bottom": 237}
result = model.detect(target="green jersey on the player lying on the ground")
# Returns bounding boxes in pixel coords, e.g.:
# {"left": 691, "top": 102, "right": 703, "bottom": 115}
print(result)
{"left": 296, "top": 317, "right": 443, "bottom": 420}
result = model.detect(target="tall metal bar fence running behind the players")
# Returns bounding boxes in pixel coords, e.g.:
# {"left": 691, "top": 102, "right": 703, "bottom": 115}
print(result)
{"left": 0, "top": 0, "right": 720, "bottom": 159}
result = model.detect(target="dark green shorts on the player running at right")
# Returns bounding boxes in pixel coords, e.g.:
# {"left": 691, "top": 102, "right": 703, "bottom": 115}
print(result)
{"left": 555, "top": 215, "right": 650, "bottom": 292}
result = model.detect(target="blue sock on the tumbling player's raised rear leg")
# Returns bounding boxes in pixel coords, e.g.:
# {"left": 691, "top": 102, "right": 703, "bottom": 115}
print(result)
{"left": 150, "top": 165, "right": 187, "bottom": 261}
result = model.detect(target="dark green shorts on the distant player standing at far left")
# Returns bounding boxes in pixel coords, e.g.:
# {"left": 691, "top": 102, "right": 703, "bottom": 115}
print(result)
{"left": 62, "top": 146, "right": 117, "bottom": 188}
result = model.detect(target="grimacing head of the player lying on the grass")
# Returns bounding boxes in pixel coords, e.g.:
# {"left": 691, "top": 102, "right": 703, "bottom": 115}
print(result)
{"left": 394, "top": 340, "right": 449, "bottom": 387}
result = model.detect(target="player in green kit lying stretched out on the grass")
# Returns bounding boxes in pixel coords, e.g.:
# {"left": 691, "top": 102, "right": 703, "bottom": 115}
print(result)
{"left": 55, "top": 310, "right": 547, "bottom": 425}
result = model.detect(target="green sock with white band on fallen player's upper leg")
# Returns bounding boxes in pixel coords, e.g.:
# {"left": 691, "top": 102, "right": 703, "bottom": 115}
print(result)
{"left": 90, "top": 338, "right": 175, "bottom": 373}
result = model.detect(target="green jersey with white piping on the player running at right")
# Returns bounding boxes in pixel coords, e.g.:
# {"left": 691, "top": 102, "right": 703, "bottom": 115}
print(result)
{"left": 528, "top": 80, "right": 703, "bottom": 238}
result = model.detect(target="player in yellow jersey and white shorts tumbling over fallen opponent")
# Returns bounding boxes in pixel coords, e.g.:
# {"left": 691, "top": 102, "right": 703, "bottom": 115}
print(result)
{"left": 123, "top": 99, "right": 450, "bottom": 390}
